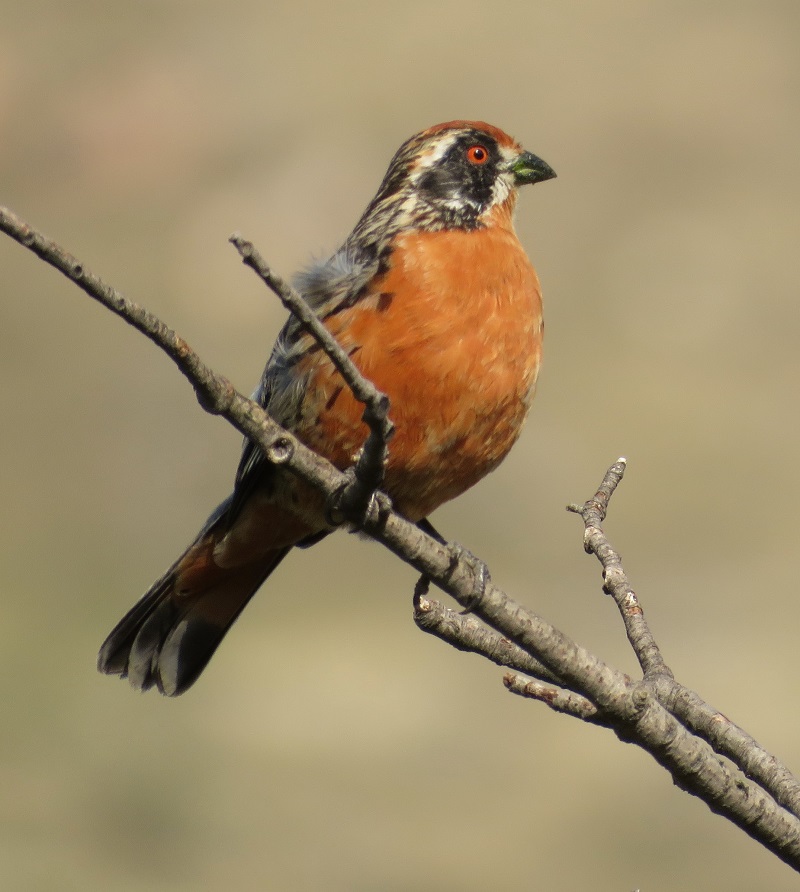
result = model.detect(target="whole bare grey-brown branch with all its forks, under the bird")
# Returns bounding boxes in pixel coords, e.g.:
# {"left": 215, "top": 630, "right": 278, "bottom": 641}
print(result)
{"left": 0, "top": 208, "right": 800, "bottom": 871}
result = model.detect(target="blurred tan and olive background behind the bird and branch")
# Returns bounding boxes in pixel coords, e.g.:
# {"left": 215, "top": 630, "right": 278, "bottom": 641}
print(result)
{"left": 0, "top": 0, "right": 800, "bottom": 892}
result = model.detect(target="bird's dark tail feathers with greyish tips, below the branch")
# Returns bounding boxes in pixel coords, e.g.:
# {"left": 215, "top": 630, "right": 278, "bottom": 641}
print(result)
{"left": 97, "top": 546, "right": 291, "bottom": 697}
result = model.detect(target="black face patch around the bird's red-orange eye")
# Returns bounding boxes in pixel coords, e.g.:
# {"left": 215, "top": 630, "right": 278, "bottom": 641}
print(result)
{"left": 417, "top": 131, "right": 501, "bottom": 220}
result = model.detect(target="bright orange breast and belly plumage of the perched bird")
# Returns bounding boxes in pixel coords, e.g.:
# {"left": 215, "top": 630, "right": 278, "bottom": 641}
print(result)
{"left": 297, "top": 220, "right": 542, "bottom": 520}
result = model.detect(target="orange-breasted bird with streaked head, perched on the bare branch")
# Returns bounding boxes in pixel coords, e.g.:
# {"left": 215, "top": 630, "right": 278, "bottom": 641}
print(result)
{"left": 98, "top": 120, "right": 556, "bottom": 696}
